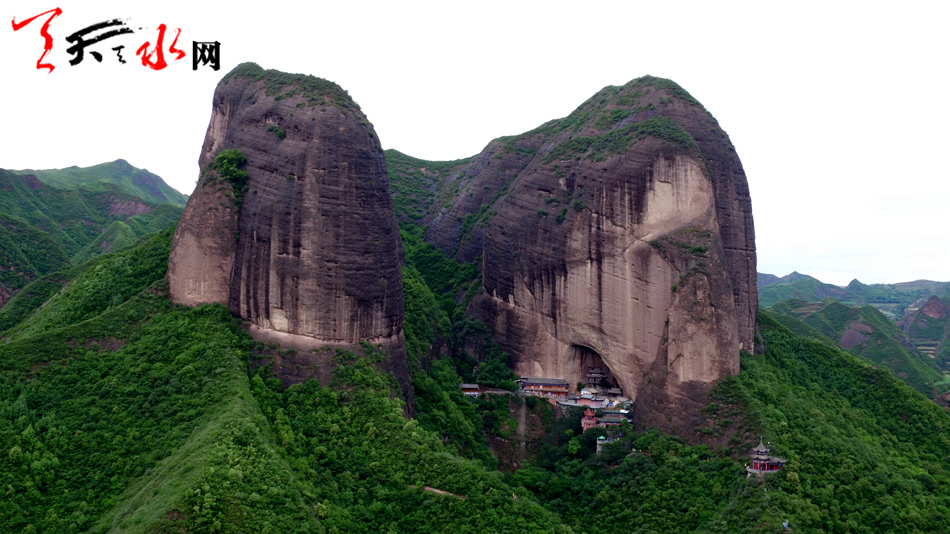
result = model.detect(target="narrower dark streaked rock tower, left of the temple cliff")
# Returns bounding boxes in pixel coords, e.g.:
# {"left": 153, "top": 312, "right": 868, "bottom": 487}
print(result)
{"left": 168, "top": 64, "right": 409, "bottom": 397}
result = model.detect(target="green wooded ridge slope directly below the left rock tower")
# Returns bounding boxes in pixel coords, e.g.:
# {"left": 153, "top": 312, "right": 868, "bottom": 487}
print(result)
{"left": 0, "top": 230, "right": 569, "bottom": 532}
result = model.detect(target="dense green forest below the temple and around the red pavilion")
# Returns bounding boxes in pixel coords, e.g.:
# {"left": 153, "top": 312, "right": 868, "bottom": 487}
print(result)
{"left": 509, "top": 314, "right": 950, "bottom": 533}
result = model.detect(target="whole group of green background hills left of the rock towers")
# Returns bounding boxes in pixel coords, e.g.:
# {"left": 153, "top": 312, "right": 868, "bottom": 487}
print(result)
{"left": 0, "top": 165, "right": 187, "bottom": 307}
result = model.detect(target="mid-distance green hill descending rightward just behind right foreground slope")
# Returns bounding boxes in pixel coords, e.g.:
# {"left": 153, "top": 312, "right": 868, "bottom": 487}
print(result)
{"left": 768, "top": 299, "right": 950, "bottom": 396}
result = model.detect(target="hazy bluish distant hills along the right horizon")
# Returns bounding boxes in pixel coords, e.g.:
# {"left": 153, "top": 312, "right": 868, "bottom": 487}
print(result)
{"left": 757, "top": 272, "right": 950, "bottom": 321}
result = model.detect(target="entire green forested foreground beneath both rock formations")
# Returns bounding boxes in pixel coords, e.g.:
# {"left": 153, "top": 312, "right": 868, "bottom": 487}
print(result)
{"left": 0, "top": 222, "right": 950, "bottom": 533}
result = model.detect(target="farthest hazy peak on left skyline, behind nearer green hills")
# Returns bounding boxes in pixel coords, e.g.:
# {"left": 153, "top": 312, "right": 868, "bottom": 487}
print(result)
{"left": 13, "top": 159, "right": 188, "bottom": 208}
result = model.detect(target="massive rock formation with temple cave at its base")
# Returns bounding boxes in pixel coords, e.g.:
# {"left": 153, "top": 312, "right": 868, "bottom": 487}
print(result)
{"left": 400, "top": 77, "right": 757, "bottom": 436}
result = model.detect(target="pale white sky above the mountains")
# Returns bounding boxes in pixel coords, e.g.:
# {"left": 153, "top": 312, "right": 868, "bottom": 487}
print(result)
{"left": 0, "top": 0, "right": 950, "bottom": 285}
